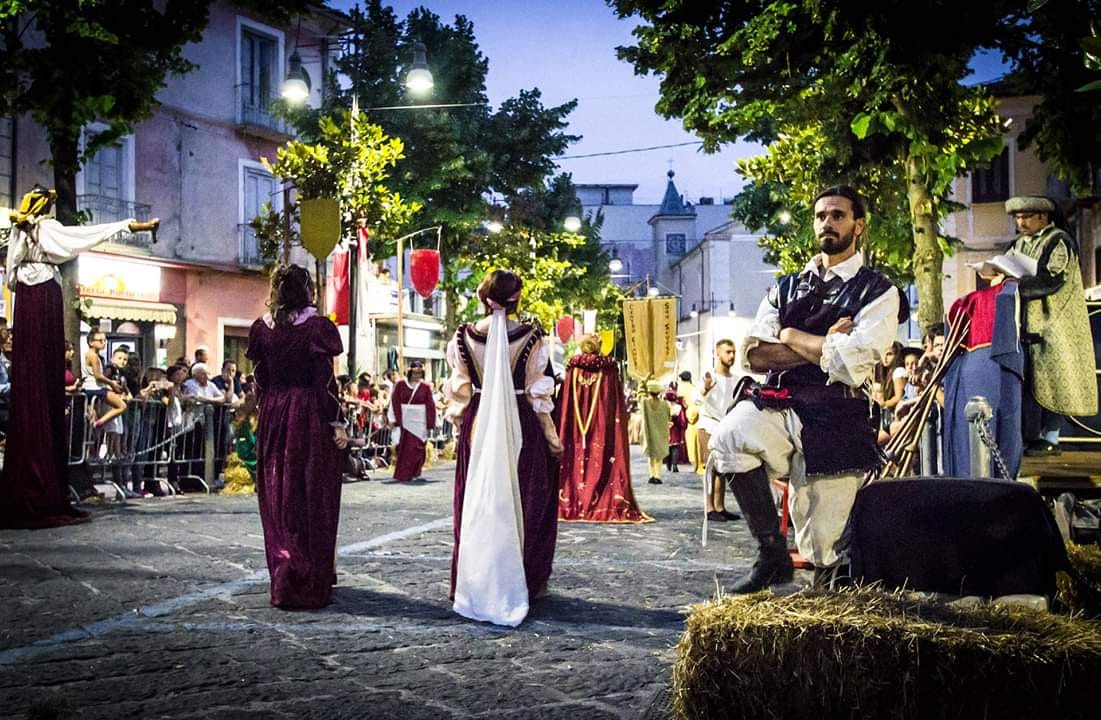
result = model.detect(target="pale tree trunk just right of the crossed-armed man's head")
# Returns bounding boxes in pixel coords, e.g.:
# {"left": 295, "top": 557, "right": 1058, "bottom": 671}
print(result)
{"left": 906, "top": 155, "right": 945, "bottom": 334}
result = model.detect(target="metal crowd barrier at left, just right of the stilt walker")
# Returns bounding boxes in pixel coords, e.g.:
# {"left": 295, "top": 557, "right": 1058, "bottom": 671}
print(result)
{"left": 67, "top": 394, "right": 233, "bottom": 499}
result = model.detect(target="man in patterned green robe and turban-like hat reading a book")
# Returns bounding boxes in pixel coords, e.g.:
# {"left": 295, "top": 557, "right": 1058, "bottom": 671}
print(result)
{"left": 1005, "top": 195, "right": 1098, "bottom": 456}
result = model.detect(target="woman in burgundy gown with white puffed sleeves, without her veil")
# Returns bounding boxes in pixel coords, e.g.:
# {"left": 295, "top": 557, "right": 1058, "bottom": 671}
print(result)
{"left": 444, "top": 270, "right": 562, "bottom": 619}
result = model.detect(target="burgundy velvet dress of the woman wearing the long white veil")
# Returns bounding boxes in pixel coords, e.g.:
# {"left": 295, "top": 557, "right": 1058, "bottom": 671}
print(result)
{"left": 451, "top": 325, "right": 558, "bottom": 600}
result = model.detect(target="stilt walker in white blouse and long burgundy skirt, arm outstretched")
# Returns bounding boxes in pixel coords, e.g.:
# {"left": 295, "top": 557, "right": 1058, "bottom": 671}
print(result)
{"left": 0, "top": 188, "right": 133, "bottom": 528}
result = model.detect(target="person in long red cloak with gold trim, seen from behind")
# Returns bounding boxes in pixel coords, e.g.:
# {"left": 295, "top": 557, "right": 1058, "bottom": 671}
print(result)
{"left": 558, "top": 335, "right": 653, "bottom": 523}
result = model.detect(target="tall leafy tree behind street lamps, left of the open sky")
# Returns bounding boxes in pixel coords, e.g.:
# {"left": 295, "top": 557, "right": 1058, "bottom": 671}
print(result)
{"left": 279, "top": 0, "right": 577, "bottom": 327}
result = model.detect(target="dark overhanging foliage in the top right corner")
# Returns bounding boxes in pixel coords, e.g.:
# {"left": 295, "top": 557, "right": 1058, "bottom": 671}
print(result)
{"left": 999, "top": 0, "right": 1101, "bottom": 196}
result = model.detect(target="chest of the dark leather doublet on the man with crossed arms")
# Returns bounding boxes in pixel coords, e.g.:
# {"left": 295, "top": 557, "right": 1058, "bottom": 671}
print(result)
{"left": 768, "top": 266, "right": 894, "bottom": 385}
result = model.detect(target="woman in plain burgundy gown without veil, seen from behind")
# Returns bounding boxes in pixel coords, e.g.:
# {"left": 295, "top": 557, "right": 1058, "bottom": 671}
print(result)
{"left": 246, "top": 265, "right": 348, "bottom": 609}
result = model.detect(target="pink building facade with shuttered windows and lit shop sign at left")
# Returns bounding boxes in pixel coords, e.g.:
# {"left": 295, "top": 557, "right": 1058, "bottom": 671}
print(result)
{"left": 0, "top": 2, "right": 346, "bottom": 369}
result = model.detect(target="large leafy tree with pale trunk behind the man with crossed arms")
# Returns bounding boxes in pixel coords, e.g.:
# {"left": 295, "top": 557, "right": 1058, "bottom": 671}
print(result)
{"left": 609, "top": 0, "right": 1007, "bottom": 324}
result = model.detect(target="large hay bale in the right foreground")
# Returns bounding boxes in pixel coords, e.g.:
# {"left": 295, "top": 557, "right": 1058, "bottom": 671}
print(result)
{"left": 673, "top": 588, "right": 1101, "bottom": 720}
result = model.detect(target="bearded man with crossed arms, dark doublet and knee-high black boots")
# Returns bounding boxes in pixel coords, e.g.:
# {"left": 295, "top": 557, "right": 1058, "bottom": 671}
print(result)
{"left": 710, "top": 186, "right": 903, "bottom": 593}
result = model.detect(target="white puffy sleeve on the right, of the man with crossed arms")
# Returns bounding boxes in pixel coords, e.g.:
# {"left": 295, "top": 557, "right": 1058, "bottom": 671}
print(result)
{"left": 819, "top": 285, "right": 898, "bottom": 388}
